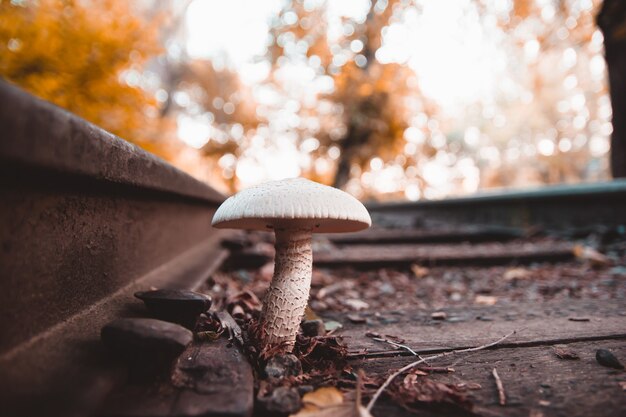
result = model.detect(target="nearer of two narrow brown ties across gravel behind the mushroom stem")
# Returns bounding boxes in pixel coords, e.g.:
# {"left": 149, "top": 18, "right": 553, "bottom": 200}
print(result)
{"left": 313, "top": 242, "right": 574, "bottom": 267}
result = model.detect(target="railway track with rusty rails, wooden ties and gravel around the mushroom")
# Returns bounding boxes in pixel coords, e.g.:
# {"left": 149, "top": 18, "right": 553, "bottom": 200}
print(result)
{"left": 0, "top": 83, "right": 626, "bottom": 416}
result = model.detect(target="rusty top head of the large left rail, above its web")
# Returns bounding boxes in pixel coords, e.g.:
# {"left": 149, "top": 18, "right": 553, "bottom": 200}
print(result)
{"left": 0, "top": 80, "right": 224, "bottom": 203}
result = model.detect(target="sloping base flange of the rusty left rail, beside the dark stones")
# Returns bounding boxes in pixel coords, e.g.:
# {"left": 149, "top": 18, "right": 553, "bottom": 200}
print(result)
{"left": 0, "top": 231, "right": 227, "bottom": 417}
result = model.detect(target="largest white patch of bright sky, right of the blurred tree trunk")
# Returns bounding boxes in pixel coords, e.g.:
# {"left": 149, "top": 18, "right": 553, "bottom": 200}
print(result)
{"left": 376, "top": 0, "right": 506, "bottom": 112}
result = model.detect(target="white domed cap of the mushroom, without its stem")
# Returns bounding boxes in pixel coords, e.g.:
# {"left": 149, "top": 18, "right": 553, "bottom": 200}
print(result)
{"left": 212, "top": 178, "right": 372, "bottom": 233}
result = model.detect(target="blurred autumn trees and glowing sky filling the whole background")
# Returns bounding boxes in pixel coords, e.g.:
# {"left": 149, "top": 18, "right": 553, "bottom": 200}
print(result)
{"left": 0, "top": 0, "right": 624, "bottom": 199}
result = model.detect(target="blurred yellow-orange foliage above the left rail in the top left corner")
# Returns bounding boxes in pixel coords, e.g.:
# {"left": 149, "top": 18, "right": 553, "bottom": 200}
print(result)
{"left": 0, "top": 0, "right": 166, "bottom": 152}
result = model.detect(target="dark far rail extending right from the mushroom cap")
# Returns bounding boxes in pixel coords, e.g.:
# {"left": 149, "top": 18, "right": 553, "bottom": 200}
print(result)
{"left": 367, "top": 180, "right": 626, "bottom": 230}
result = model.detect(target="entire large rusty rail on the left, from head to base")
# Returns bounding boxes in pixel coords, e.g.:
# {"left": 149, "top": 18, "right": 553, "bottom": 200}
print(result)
{"left": 0, "top": 82, "right": 226, "bottom": 415}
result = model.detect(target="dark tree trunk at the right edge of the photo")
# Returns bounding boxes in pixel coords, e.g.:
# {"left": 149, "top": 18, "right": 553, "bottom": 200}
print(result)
{"left": 597, "top": 0, "right": 626, "bottom": 178}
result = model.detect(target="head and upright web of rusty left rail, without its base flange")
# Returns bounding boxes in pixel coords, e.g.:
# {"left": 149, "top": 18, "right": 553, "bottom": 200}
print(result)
{"left": 0, "top": 82, "right": 223, "bottom": 354}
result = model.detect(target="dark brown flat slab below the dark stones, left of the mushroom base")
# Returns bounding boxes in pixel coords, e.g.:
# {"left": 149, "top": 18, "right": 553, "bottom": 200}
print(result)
{"left": 98, "top": 338, "right": 254, "bottom": 417}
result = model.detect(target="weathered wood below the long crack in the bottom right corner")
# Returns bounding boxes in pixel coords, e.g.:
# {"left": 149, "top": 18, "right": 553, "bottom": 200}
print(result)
{"left": 351, "top": 340, "right": 626, "bottom": 417}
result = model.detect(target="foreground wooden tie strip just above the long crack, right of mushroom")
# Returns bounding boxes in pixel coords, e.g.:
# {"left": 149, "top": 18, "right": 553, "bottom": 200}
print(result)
{"left": 332, "top": 301, "right": 626, "bottom": 356}
